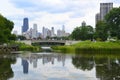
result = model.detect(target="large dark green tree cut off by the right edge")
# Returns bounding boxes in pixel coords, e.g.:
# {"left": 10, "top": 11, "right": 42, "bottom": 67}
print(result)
{"left": 105, "top": 7, "right": 120, "bottom": 39}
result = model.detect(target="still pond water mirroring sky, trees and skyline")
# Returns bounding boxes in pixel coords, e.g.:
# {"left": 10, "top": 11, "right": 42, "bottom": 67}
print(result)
{"left": 0, "top": 52, "right": 120, "bottom": 80}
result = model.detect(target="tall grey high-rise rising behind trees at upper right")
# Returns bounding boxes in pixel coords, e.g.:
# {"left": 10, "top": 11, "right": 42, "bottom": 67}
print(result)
{"left": 100, "top": 3, "right": 113, "bottom": 20}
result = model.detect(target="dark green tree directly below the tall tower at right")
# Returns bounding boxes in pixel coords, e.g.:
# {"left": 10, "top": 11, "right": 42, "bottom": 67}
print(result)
{"left": 95, "top": 21, "right": 109, "bottom": 41}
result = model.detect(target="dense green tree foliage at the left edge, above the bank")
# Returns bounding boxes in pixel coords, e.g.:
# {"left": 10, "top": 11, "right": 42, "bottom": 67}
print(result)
{"left": 0, "top": 15, "right": 14, "bottom": 44}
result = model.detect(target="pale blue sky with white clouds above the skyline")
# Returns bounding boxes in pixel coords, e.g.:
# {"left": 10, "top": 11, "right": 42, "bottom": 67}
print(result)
{"left": 0, "top": 0, "right": 120, "bottom": 34}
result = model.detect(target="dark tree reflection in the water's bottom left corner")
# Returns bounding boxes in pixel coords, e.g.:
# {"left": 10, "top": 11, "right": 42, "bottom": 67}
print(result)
{"left": 0, "top": 58, "right": 16, "bottom": 80}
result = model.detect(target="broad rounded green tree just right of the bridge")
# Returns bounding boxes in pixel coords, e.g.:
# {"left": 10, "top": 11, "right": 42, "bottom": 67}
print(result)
{"left": 71, "top": 26, "right": 94, "bottom": 40}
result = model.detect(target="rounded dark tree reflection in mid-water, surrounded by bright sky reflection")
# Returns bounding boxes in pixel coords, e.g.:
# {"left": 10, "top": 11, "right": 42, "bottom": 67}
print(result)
{"left": 72, "top": 57, "right": 94, "bottom": 70}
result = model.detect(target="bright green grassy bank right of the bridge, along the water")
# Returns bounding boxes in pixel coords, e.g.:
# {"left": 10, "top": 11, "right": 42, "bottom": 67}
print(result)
{"left": 52, "top": 41, "right": 120, "bottom": 53}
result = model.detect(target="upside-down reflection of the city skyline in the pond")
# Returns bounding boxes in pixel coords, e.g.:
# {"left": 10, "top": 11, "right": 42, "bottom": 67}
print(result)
{"left": 22, "top": 54, "right": 66, "bottom": 74}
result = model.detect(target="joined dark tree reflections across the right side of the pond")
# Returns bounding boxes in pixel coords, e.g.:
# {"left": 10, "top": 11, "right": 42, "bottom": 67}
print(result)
{"left": 72, "top": 55, "right": 120, "bottom": 80}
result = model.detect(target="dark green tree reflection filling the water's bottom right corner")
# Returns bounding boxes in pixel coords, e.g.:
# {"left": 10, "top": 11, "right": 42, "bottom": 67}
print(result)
{"left": 95, "top": 58, "right": 120, "bottom": 80}
